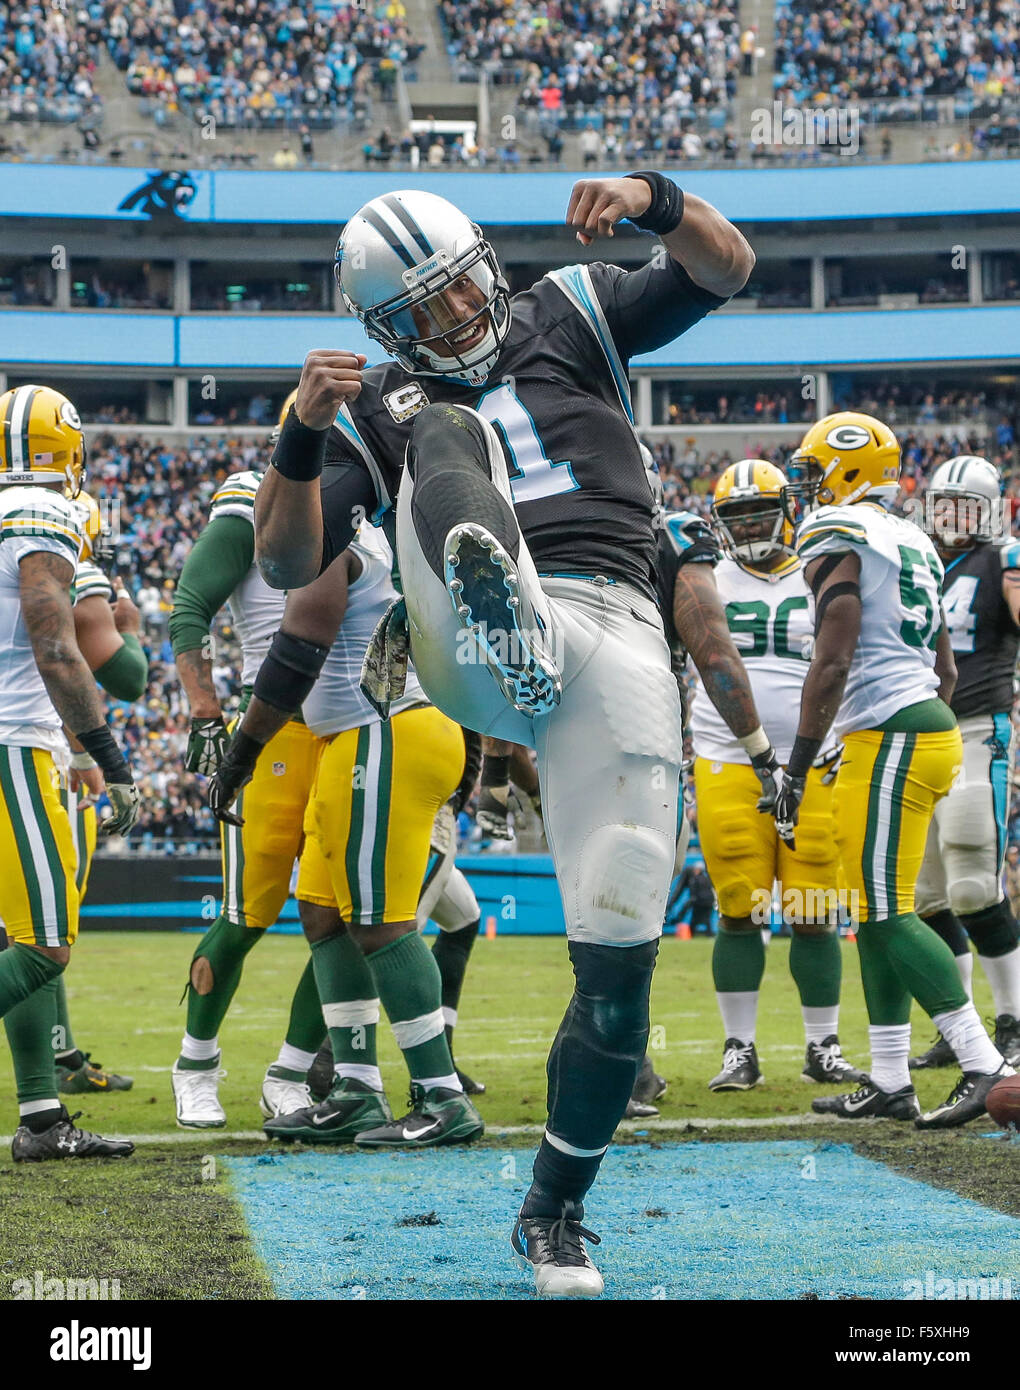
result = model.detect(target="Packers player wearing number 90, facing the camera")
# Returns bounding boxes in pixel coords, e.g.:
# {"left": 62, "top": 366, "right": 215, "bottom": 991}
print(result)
{"left": 691, "top": 459, "right": 862, "bottom": 1091}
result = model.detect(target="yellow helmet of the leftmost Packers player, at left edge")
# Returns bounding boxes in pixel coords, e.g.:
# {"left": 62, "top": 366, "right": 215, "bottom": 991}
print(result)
{"left": 0, "top": 386, "right": 85, "bottom": 498}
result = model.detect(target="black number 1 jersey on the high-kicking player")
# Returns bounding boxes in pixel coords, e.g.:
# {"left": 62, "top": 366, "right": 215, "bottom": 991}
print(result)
{"left": 321, "top": 257, "right": 725, "bottom": 596}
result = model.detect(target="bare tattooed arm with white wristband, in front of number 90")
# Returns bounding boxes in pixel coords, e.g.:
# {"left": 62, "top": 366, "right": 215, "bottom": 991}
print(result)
{"left": 673, "top": 564, "right": 762, "bottom": 738}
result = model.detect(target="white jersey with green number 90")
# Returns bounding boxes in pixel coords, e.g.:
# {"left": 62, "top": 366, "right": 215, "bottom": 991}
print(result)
{"left": 691, "top": 556, "right": 834, "bottom": 766}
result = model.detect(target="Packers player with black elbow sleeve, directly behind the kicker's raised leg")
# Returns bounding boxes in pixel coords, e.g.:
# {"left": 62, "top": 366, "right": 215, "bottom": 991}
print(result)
{"left": 210, "top": 527, "right": 484, "bottom": 1148}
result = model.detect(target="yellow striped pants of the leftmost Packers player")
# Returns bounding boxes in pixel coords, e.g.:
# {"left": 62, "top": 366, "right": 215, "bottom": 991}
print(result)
{"left": 0, "top": 744, "right": 78, "bottom": 947}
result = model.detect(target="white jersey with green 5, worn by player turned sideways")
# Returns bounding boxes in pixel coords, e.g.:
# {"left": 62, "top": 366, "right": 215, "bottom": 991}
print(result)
{"left": 796, "top": 502, "right": 945, "bottom": 737}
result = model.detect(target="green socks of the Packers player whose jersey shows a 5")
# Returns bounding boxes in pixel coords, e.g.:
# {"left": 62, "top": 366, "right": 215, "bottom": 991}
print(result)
{"left": 857, "top": 912, "right": 967, "bottom": 1024}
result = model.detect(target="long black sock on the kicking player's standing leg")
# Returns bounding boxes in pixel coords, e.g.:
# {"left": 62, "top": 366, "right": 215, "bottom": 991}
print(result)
{"left": 523, "top": 941, "right": 659, "bottom": 1216}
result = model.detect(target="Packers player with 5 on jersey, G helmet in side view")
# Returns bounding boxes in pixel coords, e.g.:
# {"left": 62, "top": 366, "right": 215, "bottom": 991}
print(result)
{"left": 774, "top": 411, "right": 1010, "bottom": 1129}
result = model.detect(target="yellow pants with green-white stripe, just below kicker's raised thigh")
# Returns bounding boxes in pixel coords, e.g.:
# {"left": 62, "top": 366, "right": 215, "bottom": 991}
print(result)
{"left": 297, "top": 705, "right": 464, "bottom": 926}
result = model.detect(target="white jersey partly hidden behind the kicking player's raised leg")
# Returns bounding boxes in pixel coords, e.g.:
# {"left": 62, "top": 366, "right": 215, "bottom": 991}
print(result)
{"left": 302, "top": 525, "right": 428, "bottom": 738}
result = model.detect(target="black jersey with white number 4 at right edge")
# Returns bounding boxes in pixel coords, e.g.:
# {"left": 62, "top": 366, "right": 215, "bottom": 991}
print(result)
{"left": 942, "top": 541, "right": 1020, "bottom": 719}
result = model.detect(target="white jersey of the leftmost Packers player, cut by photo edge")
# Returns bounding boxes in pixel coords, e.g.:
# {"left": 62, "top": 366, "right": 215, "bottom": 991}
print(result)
{"left": 0, "top": 487, "right": 82, "bottom": 756}
